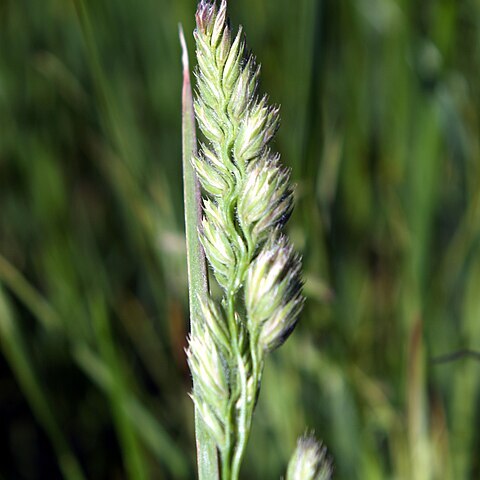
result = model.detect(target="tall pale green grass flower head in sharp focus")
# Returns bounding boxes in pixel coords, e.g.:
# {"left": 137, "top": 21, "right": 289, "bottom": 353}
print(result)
{"left": 187, "top": 0, "right": 324, "bottom": 480}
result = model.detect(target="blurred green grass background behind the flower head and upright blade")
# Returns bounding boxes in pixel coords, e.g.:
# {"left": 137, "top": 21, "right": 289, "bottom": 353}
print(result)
{"left": 0, "top": 0, "right": 480, "bottom": 480}
